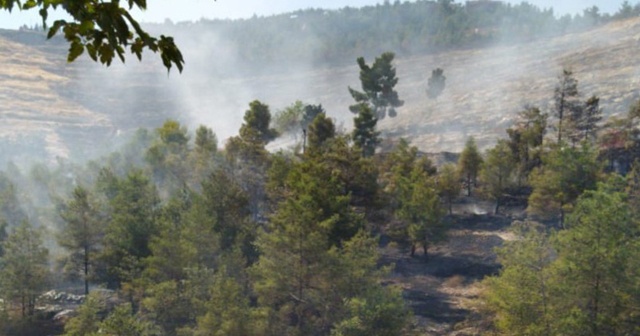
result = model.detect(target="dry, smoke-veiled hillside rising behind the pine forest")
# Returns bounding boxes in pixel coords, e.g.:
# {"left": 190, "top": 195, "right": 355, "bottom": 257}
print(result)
{"left": 0, "top": 18, "right": 640, "bottom": 160}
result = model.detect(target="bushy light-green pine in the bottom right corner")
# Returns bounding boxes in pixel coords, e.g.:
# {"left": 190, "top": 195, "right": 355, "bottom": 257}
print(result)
{"left": 557, "top": 182, "right": 640, "bottom": 336}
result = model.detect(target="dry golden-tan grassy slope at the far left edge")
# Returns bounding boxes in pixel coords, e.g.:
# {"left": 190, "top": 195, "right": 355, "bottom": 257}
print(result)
{"left": 0, "top": 33, "right": 110, "bottom": 163}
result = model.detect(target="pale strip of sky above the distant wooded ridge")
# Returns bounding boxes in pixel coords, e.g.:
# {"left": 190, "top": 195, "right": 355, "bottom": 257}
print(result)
{"left": 0, "top": 0, "right": 638, "bottom": 29}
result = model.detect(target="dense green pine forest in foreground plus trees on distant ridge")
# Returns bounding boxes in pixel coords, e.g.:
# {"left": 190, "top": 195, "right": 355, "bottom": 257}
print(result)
{"left": 0, "top": 1, "right": 640, "bottom": 336}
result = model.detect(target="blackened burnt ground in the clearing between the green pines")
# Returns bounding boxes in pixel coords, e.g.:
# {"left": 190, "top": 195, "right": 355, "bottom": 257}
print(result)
{"left": 381, "top": 201, "right": 524, "bottom": 336}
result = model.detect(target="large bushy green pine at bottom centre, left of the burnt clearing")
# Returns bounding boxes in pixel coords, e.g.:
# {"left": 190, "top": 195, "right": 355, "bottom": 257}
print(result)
{"left": 252, "top": 162, "right": 361, "bottom": 335}
